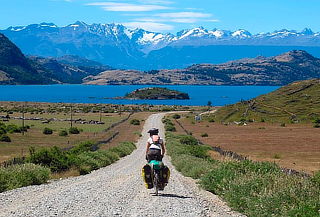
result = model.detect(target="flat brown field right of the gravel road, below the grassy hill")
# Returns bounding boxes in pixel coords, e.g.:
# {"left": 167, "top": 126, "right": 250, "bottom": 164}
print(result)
{"left": 176, "top": 115, "right": 320, "bottom": 174}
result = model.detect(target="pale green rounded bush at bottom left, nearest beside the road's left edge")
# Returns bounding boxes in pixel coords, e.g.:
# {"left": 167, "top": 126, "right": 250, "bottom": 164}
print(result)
{"left": 0, "top": 164, "right": 50, "bottom": 192}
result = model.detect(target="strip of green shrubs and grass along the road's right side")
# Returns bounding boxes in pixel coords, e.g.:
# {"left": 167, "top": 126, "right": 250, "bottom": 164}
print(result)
{"left": 166, "top": 133, "right": 320, "bottom": 217}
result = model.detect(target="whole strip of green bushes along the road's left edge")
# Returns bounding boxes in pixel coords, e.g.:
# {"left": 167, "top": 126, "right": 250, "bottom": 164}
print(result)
{"left": 0, "top": 142, "right": 136, "bottom": 192}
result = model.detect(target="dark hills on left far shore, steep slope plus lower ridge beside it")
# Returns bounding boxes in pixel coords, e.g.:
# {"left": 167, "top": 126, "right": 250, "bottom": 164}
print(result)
{"left": 0, "top": 34, "right": 111, "bottom": 84}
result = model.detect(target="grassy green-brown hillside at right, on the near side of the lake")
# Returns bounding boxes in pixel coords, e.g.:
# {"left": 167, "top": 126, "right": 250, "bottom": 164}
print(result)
{"left": 213, "top": 78, "right": 320, "bottom": 123}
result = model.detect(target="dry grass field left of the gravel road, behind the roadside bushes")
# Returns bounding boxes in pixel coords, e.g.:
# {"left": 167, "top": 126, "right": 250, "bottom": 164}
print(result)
{"left": 0, "top": 102, "right": 151, "bottom": 162}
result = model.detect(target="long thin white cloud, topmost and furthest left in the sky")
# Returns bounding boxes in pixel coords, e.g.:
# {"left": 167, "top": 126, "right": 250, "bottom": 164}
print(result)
{"left": 87, "top": 2, "right": 170, "bottom": 12}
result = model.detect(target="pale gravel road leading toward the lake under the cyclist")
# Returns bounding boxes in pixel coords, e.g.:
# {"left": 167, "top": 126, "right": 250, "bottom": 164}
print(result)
{"left": 0, "top": 114, "right": 241, "bottom": 217}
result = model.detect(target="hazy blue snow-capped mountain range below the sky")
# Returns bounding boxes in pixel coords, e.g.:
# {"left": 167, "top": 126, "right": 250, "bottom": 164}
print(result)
{"left": 0, "top": 21, "right": 320, "bottom": 70}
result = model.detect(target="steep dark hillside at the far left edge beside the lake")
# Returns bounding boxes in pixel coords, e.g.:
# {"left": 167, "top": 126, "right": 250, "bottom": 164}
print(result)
{"left": 0, "top": 33, "right": 54, "bottom": 84}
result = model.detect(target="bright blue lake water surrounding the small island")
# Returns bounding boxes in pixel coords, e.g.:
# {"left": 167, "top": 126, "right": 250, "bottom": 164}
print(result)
{"left": 0, "top": 85, "right": 279, "bottom": 106}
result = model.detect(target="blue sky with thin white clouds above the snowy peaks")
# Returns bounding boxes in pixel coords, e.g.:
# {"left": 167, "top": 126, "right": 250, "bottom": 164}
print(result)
{"left": 0, "top": 0, "right": 320, "bottom": 33}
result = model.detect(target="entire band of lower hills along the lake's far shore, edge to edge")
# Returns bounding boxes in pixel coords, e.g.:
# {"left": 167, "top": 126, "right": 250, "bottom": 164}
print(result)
{"left": 0, "top": 33, "right": 320, "bottom": 85}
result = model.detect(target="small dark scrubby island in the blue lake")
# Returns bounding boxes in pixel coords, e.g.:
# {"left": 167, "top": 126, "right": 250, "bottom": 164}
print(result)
{"left": 122, "top": 87, "right": 190, "bottom": 100}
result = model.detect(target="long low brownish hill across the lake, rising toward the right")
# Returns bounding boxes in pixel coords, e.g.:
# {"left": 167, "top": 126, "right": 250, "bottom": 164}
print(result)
{"left": 84, "top": 50, "right": 320, "bottom": 86}
